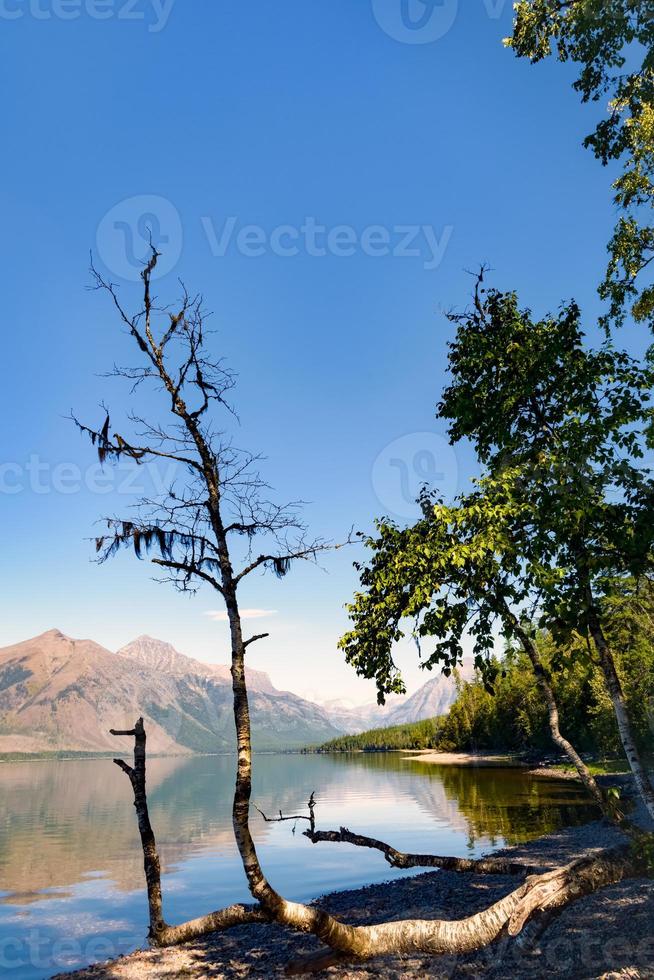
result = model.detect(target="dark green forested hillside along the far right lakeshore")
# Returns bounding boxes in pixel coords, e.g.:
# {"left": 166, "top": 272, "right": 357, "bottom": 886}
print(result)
{"left": 323, "top": 585, "right": 654, "bottom": 757}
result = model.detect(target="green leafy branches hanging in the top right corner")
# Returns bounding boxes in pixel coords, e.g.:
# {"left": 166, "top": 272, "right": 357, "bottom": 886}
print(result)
{"left": 506, "top": 0, "right": 654, "bottom": 328}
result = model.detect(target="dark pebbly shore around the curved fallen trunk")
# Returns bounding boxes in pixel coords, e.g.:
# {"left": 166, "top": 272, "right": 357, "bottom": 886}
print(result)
{"left": 60, "top": 778, "right": 654, "bottom": 980}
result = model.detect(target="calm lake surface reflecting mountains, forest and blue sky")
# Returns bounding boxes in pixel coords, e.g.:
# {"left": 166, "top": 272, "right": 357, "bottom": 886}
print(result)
{"left": 0, "top": 754, "right": 594, "bottom": 980}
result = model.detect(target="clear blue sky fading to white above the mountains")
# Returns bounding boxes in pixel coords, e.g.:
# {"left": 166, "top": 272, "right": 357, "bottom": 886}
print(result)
{"left": 0, "top": 0, "right": 632, "bottom": 701}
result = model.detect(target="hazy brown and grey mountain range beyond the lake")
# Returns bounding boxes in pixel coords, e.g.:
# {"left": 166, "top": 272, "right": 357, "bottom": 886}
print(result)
{"left": 0, "top": 630, "right": 468, "bottom": 755}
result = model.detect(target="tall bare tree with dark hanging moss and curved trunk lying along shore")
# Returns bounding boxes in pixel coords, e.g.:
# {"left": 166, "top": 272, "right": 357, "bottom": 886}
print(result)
{"left": 75, "top": 248, "right": 639, "bottom": 972}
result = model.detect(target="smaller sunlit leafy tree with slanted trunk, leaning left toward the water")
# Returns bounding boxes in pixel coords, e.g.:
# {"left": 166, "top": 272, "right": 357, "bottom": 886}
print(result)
{"left": 341, "top": 486, "right": 608, "bottom": 815}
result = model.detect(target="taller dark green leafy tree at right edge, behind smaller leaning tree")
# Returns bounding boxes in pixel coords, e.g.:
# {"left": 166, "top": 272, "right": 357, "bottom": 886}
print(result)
{"left": 440, "top": 279, "right": 654, "bottom": 815}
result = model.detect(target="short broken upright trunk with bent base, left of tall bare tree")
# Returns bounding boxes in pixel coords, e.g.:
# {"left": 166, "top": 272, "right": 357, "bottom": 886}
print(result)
{"left": 110, "top": 718, "right": 270, "bottom": 946}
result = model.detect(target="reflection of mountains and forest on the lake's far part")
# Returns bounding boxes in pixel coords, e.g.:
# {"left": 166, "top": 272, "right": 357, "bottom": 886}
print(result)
{"left": 0, "top": 755, "right": 591, "bottom": 902}
